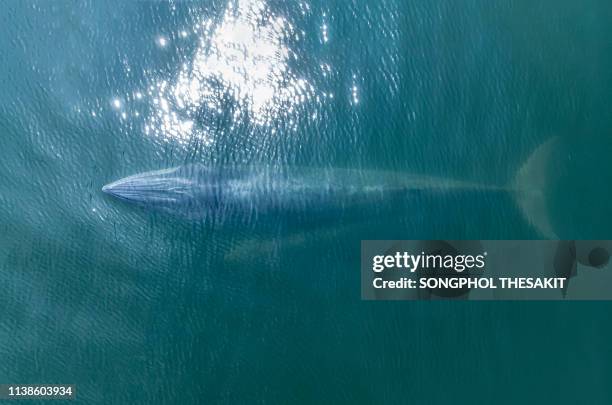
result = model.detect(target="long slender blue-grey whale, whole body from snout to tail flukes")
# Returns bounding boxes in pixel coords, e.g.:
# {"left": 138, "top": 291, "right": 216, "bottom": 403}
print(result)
{"left": 102, "top": 138, "right": 554, "bottom": 237}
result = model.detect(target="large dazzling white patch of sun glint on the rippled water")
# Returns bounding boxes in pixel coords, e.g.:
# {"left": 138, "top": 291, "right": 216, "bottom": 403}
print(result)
{"left": 143, "top": 0, "right": 316, "bottom": 142}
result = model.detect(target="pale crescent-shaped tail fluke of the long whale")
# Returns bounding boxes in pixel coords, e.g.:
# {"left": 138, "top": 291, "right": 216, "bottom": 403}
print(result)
{"left": 508, "top": 137, "right": 559, "bottom": 239}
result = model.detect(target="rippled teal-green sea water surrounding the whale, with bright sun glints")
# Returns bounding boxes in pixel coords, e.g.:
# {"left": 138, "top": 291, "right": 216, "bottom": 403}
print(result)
{"left": 0, "top": 0, "right": 612, "bottom": 405}
